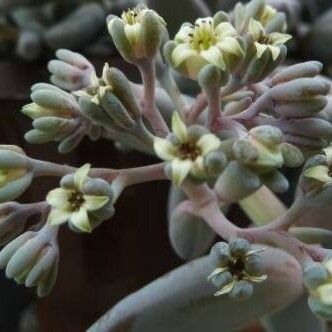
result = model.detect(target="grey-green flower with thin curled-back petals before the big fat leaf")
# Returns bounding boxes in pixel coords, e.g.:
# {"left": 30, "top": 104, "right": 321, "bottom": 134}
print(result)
{"left": 208, "top": 238, "right": 267, "bottom": 300}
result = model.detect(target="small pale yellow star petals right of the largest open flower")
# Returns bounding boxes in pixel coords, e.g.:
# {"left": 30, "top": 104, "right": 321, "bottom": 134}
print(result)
{"left": 249, "top": 18, "right": 292, "bottom": 61}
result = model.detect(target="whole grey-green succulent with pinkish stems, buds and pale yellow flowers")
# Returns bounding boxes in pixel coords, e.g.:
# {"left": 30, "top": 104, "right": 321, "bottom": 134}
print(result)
{"left": 0, "top": 0, "right": 332, "bottom": 332}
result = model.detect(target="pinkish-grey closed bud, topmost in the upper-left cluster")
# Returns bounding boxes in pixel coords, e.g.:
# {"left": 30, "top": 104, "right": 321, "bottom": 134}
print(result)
{"left": 48, "top": 49, "right": 98, "bottom": 91}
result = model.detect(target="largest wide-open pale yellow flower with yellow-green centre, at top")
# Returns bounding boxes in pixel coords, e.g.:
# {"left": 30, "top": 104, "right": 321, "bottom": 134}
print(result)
{"left": 165, "top": 14, "right": 244, "bottom": 80}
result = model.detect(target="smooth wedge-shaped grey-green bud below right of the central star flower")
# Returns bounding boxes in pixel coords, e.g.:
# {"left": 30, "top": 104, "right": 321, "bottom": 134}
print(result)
{"left": 214, "top": 161, "right": 261, "bottom": 203}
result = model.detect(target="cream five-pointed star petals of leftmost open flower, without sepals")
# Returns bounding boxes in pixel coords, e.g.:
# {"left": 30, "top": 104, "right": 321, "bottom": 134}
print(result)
{"left": 46, "top": 164, "right": 110, "bottom": 232}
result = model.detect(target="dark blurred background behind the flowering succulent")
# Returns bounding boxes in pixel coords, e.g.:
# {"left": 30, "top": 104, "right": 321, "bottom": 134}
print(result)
{"left": 0, "top": 0, "right": 332, "bottom": 332}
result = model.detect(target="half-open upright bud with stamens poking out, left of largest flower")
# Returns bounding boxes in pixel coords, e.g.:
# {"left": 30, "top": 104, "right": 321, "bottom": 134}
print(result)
{"left": 107, "top": 5, "right": 166, "bottom": 63}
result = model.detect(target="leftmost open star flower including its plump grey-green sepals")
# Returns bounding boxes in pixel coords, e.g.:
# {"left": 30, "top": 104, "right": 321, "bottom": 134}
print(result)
{"left": 46, "top": 164, "right": 114, "bottom": 232}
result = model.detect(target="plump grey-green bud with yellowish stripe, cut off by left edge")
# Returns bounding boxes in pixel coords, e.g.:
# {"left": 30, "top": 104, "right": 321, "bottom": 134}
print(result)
{"left": 0, "top": 145, "right": 33, "bottom": 202}
